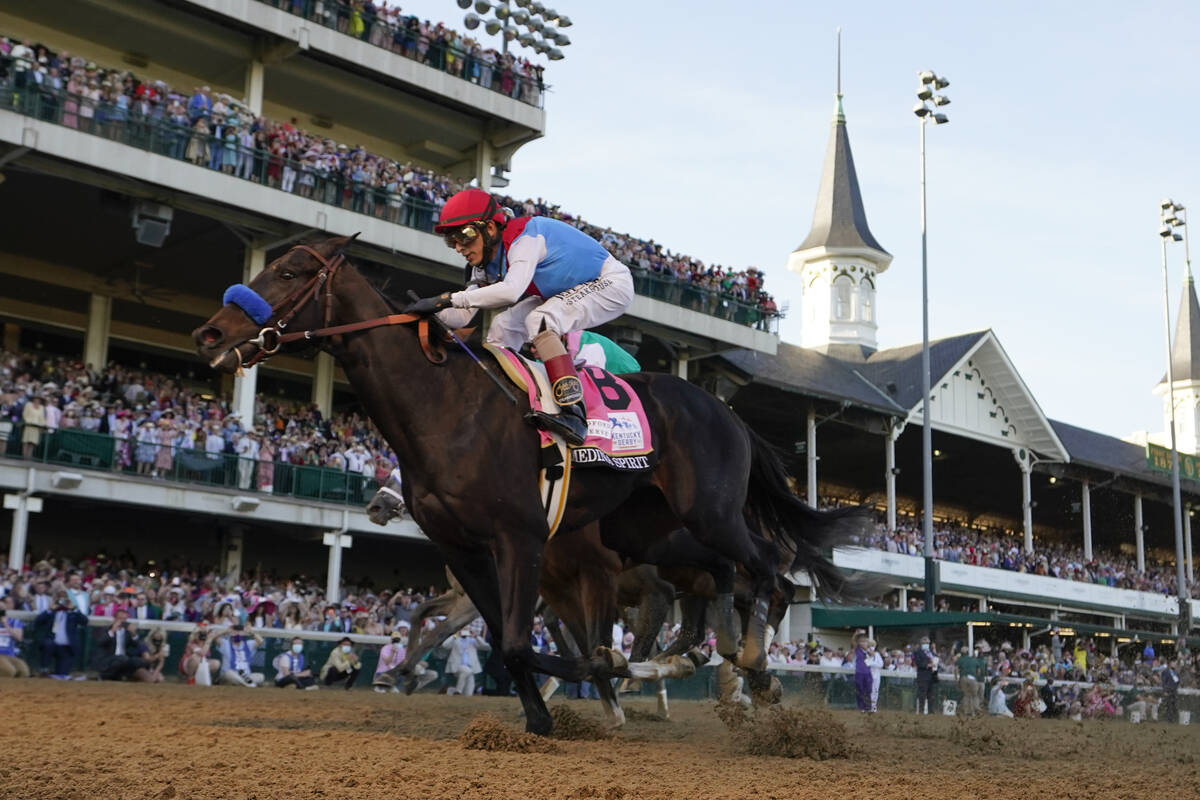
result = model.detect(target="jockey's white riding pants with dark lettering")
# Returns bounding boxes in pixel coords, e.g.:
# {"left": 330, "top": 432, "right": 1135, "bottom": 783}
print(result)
{"left": 487, "top": 255, "right": 634, "bottom": 350}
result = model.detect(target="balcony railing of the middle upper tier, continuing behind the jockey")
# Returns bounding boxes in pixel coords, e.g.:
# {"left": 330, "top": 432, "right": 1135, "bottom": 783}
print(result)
{"left": 0, "top": 72, "right": 780, "bottom": 333}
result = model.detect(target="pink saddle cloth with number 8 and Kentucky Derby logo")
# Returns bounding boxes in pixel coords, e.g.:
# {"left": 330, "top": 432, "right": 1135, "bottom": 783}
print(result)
{"left": 493, "top": 348, "right": 654, "bottom": 471}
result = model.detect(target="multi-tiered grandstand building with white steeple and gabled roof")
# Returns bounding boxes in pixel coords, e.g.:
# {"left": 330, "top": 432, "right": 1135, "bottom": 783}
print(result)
{"left": 0, "top": 0, "right": 1200, "bottom": 676}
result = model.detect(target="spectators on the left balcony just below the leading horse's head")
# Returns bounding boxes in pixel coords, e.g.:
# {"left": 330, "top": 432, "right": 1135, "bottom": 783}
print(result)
{"left": 0, "top": 350, "right": 397, "bottom": 492}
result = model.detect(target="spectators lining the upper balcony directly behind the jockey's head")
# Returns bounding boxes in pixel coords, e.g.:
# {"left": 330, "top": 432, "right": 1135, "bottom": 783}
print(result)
{"left": 0, "top": 38, "right": 780, "bottom": 330}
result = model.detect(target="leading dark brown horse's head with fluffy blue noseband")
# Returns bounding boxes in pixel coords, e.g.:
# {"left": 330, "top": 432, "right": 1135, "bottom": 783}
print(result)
{"left": 192, "top": 236, "right": 354, "bottom": 372}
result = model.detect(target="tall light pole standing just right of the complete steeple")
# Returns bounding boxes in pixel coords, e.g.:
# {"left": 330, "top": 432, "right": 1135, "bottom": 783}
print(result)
{"left": 912, "top": 70, "right": 950, "bottom": 610}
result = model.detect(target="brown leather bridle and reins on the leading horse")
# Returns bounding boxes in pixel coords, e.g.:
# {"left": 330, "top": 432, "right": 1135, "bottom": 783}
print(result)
{"left": 234, "top": 245, "right": 463, "bottom": 367}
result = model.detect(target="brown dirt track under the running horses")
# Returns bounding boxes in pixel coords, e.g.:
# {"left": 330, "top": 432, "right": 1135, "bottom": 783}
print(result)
{"left": 9, "top": 680, "right": 1200, "bottom": 800}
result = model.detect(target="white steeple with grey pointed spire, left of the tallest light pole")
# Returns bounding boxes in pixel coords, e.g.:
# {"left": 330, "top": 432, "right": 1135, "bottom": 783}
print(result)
{"left": 787, "top": 29, "right": 892, "bottom": 357}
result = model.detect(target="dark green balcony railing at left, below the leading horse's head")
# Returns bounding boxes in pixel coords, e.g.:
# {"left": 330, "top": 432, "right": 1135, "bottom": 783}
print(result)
{"left": 0, "top": 425, "right": 379, "bottom": 505}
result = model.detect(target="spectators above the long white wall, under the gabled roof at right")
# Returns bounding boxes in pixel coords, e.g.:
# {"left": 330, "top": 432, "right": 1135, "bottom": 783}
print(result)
{"left": 859, "top": 519, "right": 1200, "bottom": 596}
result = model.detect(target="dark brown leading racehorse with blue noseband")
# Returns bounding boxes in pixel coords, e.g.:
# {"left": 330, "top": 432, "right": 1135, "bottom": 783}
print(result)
{"left": 193, "top": 237, "right": 865, "bottom": 734}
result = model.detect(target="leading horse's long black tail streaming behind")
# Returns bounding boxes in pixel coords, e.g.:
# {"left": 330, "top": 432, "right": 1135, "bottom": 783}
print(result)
{"left": 745, "top": 426, "right": 876, "bottom": 597}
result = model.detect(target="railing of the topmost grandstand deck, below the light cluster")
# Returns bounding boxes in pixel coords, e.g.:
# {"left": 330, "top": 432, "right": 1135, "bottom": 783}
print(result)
{"left": 258, "top": 0, "right": 547, "bottom": 108}
